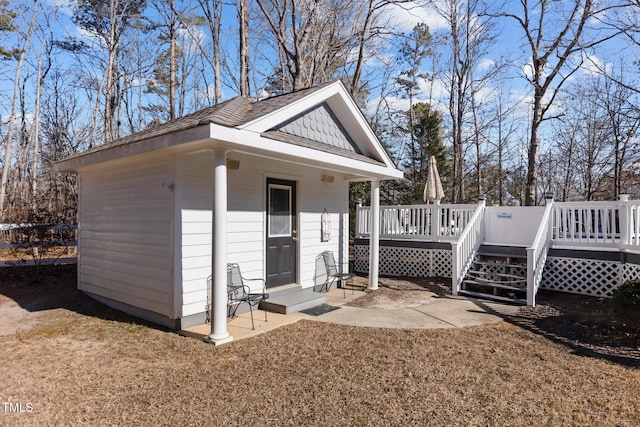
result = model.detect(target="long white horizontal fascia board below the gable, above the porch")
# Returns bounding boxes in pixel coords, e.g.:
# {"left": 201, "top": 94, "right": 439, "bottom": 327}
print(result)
{"left": 210, "top": 123, "right": 403, "bottom": 180}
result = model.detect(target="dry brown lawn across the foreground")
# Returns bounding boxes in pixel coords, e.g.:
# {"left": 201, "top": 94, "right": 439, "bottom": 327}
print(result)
{"left": 0, "top": 267, "right": 640, "bottom": 426}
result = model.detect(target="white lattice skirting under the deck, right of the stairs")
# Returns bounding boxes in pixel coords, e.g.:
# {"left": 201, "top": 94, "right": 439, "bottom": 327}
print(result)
{"left": 540, "top": 257, "right": 640, "bottom": 297}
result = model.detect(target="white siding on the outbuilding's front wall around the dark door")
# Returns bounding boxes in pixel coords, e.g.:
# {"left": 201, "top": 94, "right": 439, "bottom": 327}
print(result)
{"left": 176, "top": 153, "right": 348, "bottom": 316}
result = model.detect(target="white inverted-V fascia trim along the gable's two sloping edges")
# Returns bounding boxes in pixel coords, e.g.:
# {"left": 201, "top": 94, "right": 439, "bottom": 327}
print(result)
{"left": 238, "top": 81, "right": 394, "bottom": 168}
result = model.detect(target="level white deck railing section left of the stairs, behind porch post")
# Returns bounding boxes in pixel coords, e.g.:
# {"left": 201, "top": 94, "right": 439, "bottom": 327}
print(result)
{"left": 356, "top": 205, "right": 477, "bottom": 241}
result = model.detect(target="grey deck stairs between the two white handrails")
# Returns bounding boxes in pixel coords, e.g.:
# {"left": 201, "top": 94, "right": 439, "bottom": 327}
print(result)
{"left": 459, "top": 245, "right": 527, "bottom": 305}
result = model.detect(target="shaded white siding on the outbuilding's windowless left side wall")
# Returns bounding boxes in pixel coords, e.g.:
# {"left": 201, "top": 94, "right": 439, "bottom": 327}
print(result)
{"left": 78, "top": 158, "right": 173, "bottom": 318}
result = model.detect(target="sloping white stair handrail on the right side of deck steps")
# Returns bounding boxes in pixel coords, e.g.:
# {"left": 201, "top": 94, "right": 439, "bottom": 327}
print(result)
{"left": 527, "top": 198, "right": 553, "bottom": 307}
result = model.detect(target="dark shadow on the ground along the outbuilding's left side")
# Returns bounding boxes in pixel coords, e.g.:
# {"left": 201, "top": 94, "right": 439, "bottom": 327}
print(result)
{"left": 0, "top": 264, "right": 169, "bottom": 331}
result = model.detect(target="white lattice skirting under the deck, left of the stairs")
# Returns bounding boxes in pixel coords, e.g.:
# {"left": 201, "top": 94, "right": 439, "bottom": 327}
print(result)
{"left": 354, "top": 245, "right": 451, "bottom": 277}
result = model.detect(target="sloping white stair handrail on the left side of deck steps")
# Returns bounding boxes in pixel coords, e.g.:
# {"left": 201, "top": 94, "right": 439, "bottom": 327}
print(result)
{"left": 451, "top": 199, "right": 485, "bottom": 295}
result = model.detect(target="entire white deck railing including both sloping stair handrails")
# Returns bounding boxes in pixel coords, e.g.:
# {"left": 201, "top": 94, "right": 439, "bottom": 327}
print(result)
{"left": 356, "top": 195, "right": 640, "bottom": 305}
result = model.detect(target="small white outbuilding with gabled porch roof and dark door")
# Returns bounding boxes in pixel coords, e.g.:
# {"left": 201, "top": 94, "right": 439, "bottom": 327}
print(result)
{"left": 56, "top": 82, "right": 402, "bottom": 343}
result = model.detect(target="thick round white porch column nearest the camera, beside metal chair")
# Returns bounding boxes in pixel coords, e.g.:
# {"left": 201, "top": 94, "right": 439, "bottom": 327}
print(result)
{"left": 207, "top": 150, "right": 233, "bottom": 345}
